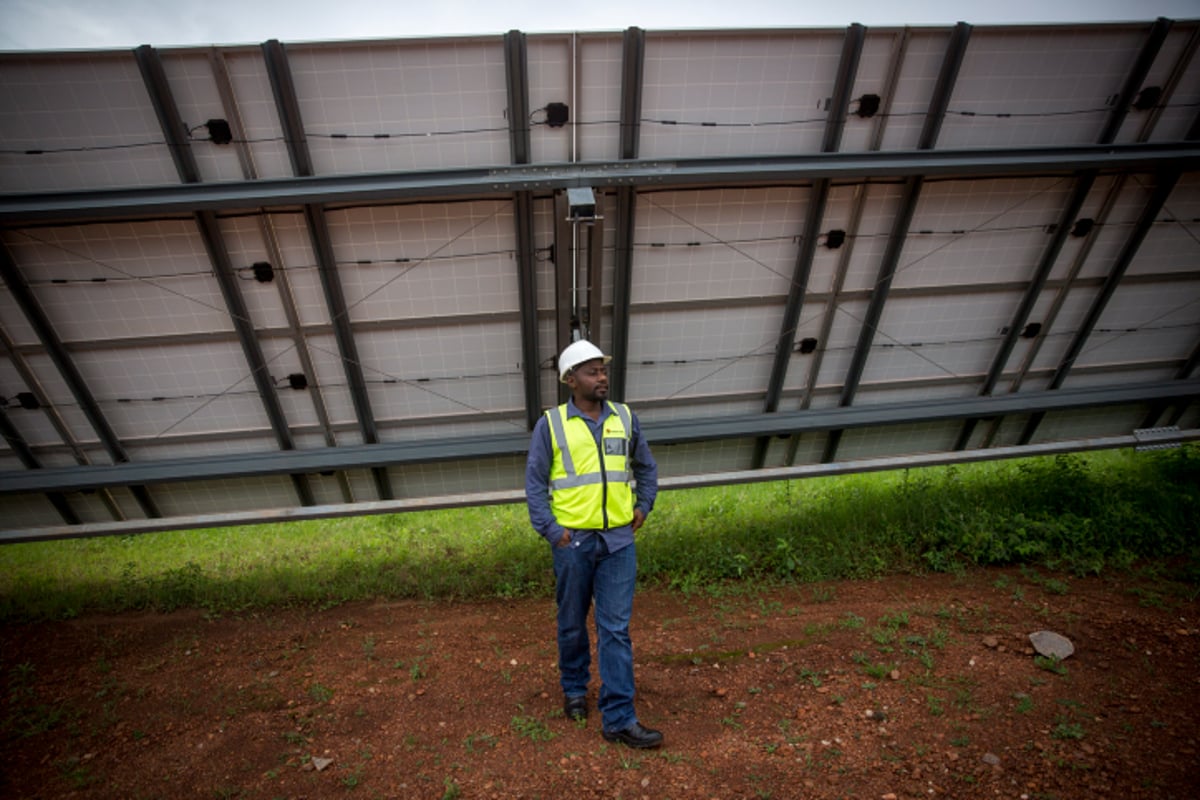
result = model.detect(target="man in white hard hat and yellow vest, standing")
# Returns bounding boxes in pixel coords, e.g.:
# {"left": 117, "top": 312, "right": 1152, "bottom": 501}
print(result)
{"left": 526, "top": 341, "right": 662, "bottom": 748}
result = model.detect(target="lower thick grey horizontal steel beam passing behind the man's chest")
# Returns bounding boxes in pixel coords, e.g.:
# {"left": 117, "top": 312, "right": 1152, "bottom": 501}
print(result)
{"left": 0, "top": 380, "right": 1200, "bottom": 494}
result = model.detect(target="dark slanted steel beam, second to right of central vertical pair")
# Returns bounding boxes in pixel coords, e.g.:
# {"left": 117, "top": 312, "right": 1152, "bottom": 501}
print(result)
{"left": 822, "top": 23, "right": 971, "bottom": 462}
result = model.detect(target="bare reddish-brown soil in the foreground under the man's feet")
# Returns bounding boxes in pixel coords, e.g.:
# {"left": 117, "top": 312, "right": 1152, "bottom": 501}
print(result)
{"left": 0, "top": 570, "right": 1200, "bottom": 800}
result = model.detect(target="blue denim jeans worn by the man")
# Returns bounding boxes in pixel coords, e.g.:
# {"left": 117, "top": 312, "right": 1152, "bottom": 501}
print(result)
{"left": 553, "top": 531, "right": 637, "bottom": 730}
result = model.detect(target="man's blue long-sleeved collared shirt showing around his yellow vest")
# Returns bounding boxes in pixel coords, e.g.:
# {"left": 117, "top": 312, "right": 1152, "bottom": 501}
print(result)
{"left": 526, "top": 398, "right": 659, "bottom": 553}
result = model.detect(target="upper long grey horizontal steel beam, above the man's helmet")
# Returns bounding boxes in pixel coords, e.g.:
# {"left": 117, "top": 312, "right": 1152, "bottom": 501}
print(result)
{"left": 0, "top": 143, "right": 1200, "bottom": 224}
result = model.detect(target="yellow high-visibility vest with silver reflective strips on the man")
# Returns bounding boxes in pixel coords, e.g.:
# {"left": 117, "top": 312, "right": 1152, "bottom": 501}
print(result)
{"left": 546, "top": 403, "right": 634, "bottom": 530}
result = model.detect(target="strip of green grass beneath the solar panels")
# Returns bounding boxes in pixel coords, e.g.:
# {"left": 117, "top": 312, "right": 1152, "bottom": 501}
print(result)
{"left": 0, "top": 446, "right": 1200, "bottom": 623}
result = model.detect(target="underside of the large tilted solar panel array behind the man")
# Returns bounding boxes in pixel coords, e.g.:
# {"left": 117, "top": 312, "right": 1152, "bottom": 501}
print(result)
{"left": 0, "top": 19, "right": 1200, "bottom": 541}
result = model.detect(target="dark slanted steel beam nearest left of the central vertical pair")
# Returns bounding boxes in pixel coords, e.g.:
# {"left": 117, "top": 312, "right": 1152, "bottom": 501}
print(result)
{"left": 263, "top": 40, "right": 394, "bottom": 500}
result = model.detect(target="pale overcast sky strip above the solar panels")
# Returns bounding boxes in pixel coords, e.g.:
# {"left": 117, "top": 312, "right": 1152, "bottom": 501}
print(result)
{"left": 0, "top": 0, "right": 1200, "bottom": 50}
